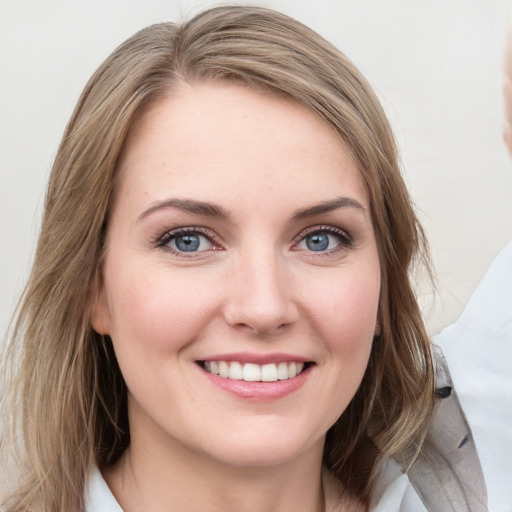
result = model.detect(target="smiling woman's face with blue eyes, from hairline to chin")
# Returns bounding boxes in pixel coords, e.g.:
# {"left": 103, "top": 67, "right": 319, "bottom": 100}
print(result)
{"left": 93, "top": 83, "right": 380, "bottom": 465}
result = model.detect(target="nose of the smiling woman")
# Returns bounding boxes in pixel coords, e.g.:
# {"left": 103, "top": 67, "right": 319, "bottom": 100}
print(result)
{"left": 224, "top": 251, "right": 299, "bottom": 336}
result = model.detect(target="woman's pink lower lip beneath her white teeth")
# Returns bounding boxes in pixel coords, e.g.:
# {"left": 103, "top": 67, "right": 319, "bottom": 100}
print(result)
{"left": 201, "top": 366, "right": 312, "bottom": 401}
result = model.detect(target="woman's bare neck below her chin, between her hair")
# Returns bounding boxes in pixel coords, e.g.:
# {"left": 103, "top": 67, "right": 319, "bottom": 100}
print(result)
{"left": 104, "top": 436, "right": 325, "bottom": 512}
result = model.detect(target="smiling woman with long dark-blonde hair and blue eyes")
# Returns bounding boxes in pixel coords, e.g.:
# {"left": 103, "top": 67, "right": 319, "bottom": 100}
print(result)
{"left": 0, "top": 7, "right": 486, "bottom": 512}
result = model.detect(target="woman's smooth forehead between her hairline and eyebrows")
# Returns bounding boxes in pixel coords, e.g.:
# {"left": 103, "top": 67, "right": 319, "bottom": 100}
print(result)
{"left": 116, "top": 82, "right": 365, "bottom": 208}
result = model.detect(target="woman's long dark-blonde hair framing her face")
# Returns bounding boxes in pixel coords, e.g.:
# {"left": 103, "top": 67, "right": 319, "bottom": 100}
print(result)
{"left": 0, "top": 6, "right": 434, "bottom": 512}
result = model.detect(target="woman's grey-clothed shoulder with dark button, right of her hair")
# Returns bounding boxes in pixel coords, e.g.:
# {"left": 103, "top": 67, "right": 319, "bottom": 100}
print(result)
{"left": 370, "top": 346, "right": 487, "bottom": 512}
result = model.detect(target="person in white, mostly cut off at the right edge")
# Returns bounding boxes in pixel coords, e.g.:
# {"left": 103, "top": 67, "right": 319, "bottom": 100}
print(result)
{"left": 434, "top": 14, "right": 512, "bottom": 512}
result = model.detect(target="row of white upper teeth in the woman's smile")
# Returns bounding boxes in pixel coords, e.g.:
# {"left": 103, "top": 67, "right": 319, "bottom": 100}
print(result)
{"left": 204, "top": 361, "right": 304, "bottom": 382}
